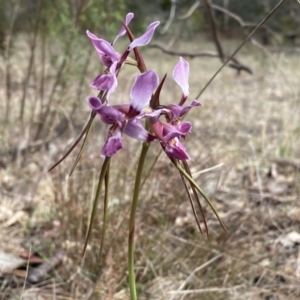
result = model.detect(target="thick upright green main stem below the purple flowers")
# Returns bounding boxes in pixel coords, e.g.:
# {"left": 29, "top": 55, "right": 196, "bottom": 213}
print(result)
{"left": 128, "top": 143, "right": 150, "bottom": 300}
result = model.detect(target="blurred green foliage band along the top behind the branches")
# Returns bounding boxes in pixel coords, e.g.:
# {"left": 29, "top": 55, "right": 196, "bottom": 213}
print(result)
{"left": 0, "top": 0, "right": 300, "bottom": 44}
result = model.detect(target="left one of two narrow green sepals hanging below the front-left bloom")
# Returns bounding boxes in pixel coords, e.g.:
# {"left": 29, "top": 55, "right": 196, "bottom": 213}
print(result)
{"left": 81, "top": 157, "right": 110, "bottom": 258}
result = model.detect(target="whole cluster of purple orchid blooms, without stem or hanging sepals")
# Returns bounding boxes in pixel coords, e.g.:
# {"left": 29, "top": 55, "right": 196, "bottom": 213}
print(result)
{"left": 87, "top": 13, "right": 201, "bottom": 160}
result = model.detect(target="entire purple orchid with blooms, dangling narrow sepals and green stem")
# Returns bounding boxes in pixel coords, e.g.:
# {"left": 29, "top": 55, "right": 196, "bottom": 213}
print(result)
{"left": 50, "top": 13, "right": 226, "bottom": 300}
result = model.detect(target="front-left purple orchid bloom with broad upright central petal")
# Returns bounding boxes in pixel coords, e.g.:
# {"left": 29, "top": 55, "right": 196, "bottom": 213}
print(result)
{"left": 89, "top": 71, "right": 158, "bottom": 157}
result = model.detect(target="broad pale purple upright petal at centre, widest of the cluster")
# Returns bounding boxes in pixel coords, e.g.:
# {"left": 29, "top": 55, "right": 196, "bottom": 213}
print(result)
{"left": 130, "top": 71, "right": 159, "bottom": 114}
